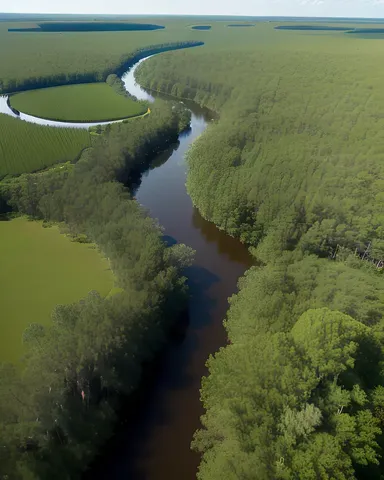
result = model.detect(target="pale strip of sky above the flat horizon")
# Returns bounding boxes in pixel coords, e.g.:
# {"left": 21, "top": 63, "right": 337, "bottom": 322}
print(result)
{"left": 0, "top": 0, "right": 384, "bottom": 18}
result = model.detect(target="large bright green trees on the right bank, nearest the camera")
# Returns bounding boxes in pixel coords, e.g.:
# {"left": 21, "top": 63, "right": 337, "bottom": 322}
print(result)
{"left": 193, "top": 254, "right": 384, "bottom": 480}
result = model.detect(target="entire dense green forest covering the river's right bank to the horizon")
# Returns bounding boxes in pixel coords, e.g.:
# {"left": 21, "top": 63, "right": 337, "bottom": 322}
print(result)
{"left": 137, "top": 21, "right": 384, "bottom": 480}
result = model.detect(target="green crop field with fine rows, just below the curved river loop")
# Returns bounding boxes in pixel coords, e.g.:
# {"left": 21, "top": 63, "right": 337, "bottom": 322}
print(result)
{"left": 0, "top": 114, "right": 91, "bottom": 178}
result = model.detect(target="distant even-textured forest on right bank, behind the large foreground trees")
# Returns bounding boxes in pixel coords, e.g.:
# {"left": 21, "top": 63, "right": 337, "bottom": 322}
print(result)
{"left": 137, "top": 24, "right": 384, "bottom": 258}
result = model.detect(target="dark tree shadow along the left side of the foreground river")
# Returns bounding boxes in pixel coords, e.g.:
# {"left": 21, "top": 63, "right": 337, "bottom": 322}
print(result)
{"left": 85, "top": 262, "right": 220, "bottom": 480}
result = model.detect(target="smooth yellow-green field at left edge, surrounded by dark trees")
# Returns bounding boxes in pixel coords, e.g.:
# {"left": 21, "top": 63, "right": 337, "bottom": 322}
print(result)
{"left": 0, "top": 218, "right": 113, "bottom": 362}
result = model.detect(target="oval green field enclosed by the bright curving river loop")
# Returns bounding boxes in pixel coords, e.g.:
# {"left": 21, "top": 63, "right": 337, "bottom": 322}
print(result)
{"left": 11, "top": 83, "right": 147, "bottom": 122}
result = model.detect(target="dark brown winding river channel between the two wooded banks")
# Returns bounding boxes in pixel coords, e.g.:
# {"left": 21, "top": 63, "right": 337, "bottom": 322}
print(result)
{"left": 87, "top": 53, "right": 251, "bottom": 480}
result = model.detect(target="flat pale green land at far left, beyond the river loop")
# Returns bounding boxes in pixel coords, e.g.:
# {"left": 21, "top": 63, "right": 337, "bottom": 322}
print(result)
{"left": 0, "top": 14, "right": 202, "bottom": 93}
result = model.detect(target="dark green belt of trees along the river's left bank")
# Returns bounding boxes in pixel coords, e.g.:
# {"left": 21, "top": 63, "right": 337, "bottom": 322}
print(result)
{"left": 0, "top": 102, "right": 193, "bottom": 480}
